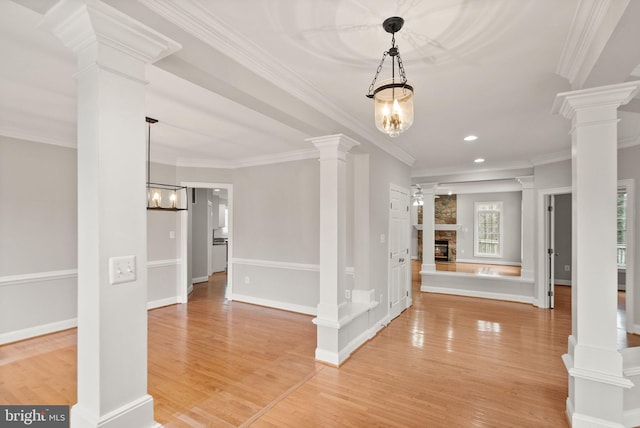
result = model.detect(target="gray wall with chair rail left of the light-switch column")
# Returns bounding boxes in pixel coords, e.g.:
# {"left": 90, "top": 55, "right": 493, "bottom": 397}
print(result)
{"left": 0, "top": 136, "right": 77, "bottom": 343}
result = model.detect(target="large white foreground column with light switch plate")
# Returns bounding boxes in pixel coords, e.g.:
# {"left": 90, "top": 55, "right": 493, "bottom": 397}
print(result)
{"left": 42, "top": 0, "right": 179, "bottom": 428}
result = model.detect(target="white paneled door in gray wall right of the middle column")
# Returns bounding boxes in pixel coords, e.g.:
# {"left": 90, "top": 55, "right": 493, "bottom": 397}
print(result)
{"left": 389, "top": 186, "right": 411, "bottom": 319}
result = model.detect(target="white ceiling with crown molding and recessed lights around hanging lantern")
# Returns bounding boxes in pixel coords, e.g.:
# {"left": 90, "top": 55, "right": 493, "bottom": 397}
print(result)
{"left": 0, "top": 0, "right": 640, "bottom": 178}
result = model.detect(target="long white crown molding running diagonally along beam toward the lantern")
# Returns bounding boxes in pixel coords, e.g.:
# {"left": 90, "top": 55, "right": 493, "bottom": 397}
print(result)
{"left": 140, "top": 0, "right": 415, "bottom": 166}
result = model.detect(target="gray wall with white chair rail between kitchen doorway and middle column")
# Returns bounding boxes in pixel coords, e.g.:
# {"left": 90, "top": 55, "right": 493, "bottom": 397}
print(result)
{"left": 232, "top": 159, "right": 320, "bottom": 313}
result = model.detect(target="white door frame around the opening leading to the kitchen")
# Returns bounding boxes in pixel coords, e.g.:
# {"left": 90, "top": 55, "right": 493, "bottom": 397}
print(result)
{"left": 177, "top": 181, "right": 233, "bottom": 303}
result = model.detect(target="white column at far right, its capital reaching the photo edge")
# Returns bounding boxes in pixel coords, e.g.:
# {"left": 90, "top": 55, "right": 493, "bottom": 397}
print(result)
{"left": 554, "top": 81, "right": 640, "bottom": 428}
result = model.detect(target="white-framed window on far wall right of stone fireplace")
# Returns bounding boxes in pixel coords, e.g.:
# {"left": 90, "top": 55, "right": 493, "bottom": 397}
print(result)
{"left": 474, "top": 202, "right": 502, "bottom": 257}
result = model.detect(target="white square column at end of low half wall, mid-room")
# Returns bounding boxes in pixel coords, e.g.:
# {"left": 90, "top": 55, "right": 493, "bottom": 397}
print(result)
{"left": 309, "top": 134, "right": 359, "bottom": 365}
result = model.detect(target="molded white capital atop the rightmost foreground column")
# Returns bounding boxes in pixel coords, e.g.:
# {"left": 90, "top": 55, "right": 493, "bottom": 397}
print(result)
{"left": 551, "top": 80, "right": 640, "bottom": 119}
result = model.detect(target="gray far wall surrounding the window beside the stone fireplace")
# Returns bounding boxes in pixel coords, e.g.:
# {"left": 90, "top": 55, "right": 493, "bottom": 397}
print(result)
{"left": 456, "top": 192, "right": 522, "bottom": 264}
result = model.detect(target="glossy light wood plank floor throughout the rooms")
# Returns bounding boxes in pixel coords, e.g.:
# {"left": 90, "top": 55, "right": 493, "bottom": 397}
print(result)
{"left": 0, "top": 266, "right": 640, "bottom": 427}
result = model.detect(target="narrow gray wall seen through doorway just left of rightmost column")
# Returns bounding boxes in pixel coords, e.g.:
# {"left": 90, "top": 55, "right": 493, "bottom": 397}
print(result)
{"left": 554, "top": 193, "right": 571, "bottom": 285}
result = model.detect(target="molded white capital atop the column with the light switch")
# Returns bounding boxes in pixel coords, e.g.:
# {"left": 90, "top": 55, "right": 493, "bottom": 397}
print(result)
{"left": 40, "top": 0, "right": 182, "bottom": 63}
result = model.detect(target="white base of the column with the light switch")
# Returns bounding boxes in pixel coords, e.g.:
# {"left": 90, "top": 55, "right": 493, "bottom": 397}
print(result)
{"left": 70, "top": 395, "right": 162, "bottom": 428}
